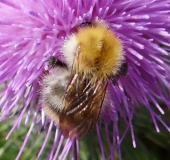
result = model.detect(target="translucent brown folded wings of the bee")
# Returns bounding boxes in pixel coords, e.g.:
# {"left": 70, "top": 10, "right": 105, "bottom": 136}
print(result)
{"left": 60, "top": 70, "right": 107, "bottom": 139}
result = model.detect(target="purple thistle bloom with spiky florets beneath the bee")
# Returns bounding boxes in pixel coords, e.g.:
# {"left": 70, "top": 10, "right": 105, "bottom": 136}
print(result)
{"left": 0, "top": 0, "right": 170, "bottom": 160}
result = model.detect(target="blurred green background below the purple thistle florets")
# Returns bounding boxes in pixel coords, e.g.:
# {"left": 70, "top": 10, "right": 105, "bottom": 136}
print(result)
{"left": 0, "top": 105, "right": 170, "bottom": 160}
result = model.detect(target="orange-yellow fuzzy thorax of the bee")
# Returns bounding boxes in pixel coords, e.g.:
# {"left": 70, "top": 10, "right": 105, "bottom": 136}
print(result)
{"left": 76, "top": 25, "right": 124, "bottom": 79}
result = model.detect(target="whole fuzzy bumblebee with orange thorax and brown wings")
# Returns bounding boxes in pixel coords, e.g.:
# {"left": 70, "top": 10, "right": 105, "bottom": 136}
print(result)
{"left": 42, "top": 21, "right": 124, "bottom": 138}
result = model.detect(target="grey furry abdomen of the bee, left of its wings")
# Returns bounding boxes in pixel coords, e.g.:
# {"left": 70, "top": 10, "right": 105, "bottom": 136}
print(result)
{"left": 42, "top": 67, "right": 70, "bottom": 123}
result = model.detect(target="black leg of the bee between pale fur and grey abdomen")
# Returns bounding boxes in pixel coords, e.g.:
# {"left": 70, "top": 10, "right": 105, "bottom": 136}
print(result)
{"left": 48, "top": 56, "right": 67, "bottom": 68}
